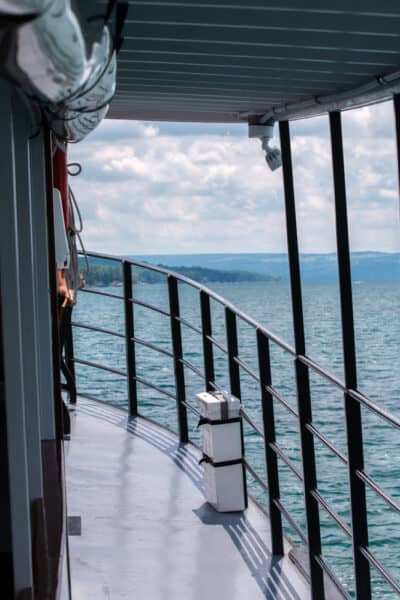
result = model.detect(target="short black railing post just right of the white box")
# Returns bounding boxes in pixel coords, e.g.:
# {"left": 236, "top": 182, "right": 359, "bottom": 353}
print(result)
{"left": 257, "top": 329, "right": 284, "bottom": 556}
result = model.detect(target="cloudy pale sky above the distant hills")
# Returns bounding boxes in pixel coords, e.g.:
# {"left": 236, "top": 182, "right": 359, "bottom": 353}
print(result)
{"left": 69, "top": 103, "right": 400, "bottom": 255}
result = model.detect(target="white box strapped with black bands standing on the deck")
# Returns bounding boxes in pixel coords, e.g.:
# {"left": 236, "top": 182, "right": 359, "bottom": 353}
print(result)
{"left": 196, "top": 392, "right": 247, "bottom": 512}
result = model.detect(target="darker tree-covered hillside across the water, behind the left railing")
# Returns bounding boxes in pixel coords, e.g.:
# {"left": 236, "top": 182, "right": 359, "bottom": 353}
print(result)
{"left": 81, "top": 258, "right": 278, "bottom": 286}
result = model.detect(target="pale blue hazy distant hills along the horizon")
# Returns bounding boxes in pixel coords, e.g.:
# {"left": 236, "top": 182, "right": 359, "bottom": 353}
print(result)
{"left": 129, "top": 252, "right": 400, "bottom": 282}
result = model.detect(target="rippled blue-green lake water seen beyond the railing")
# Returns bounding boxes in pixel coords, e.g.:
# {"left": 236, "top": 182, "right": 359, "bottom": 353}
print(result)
{"left": 74, "top": 282, "right": 400, "bottom": 599}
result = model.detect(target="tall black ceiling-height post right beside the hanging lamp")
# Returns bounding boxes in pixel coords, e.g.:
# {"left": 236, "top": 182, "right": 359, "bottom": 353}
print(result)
{"left": 279, "top": 121, "right": 325, "bottom": 600}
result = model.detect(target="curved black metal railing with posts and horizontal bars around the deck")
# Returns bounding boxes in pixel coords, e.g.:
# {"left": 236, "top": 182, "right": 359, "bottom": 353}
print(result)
{"left": 65, "top": 253, "right": 400, "bottom": 599}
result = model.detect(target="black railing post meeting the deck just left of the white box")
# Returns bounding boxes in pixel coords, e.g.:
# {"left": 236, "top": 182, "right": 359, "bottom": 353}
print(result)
{"left": 168, "top": 275, "right": 189, "bottom": 444}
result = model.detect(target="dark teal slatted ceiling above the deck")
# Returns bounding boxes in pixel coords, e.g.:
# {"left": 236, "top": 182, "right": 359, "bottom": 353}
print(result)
{"left": 96, "top": 0, "right": 400, "bottom": 122}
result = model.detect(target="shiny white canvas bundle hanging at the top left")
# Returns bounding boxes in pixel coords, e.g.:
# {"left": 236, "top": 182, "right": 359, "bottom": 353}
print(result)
{"left": 0, "top": 0, "right": 117, "bottom": 142}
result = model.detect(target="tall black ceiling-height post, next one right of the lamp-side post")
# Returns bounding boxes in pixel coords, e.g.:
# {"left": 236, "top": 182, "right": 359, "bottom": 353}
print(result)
{"left": 329, "top": 112, "right": 371, "bottom": 600}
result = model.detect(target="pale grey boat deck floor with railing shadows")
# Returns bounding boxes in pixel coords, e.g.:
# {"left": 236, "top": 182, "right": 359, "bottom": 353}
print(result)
{"left": 65, "top": 398, "right": 309, "bottom": 600}
